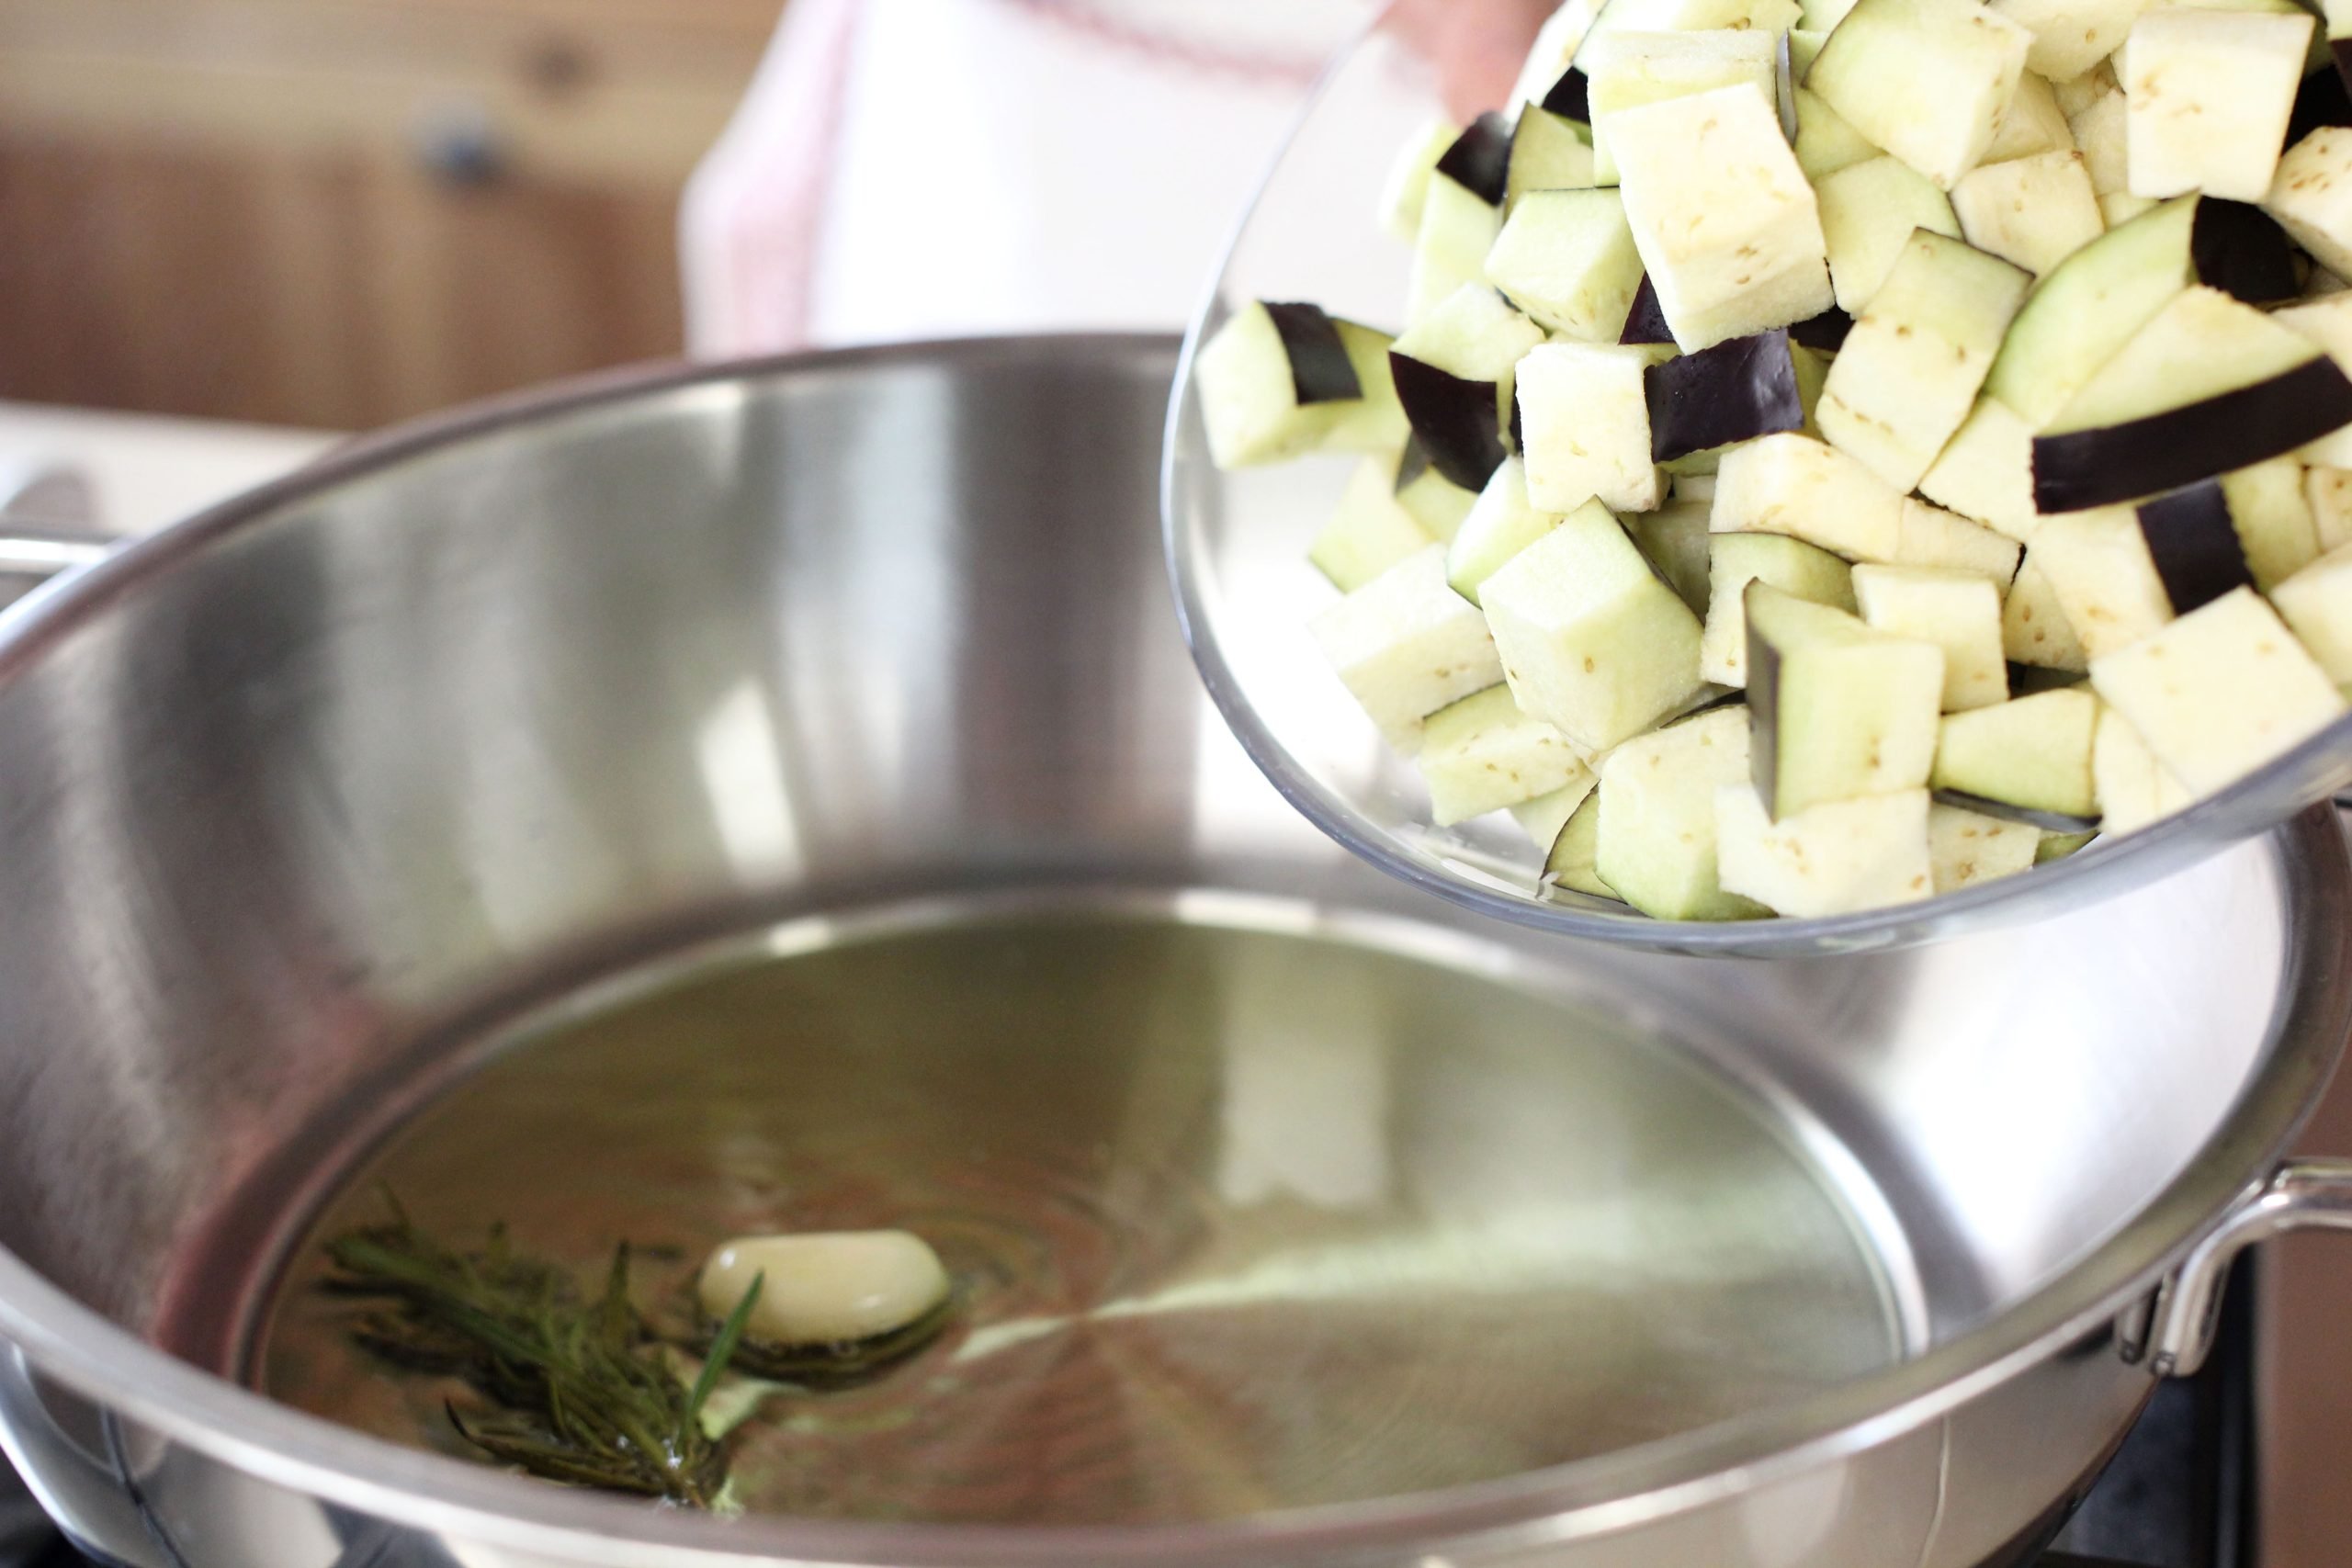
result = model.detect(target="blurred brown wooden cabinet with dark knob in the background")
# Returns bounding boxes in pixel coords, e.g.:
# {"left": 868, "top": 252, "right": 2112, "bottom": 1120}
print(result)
{"left": 0, "top": 0, "right": 781, "bottom": 430}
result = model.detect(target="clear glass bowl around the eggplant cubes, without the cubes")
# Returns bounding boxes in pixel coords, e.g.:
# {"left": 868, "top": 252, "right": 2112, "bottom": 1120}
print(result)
{"left": 1162, "top": 33, "right": 2352, "bottom": 957}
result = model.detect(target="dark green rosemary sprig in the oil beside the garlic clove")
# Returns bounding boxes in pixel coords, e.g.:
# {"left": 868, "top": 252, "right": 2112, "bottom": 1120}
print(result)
{"left": 327, "top": 1203, "right": 762, "bottom": 1506}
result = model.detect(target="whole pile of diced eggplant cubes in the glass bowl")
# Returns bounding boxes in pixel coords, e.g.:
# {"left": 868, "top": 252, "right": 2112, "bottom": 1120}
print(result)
{"left": 1197, "top": 0, "right": 2352, "bottom": 919}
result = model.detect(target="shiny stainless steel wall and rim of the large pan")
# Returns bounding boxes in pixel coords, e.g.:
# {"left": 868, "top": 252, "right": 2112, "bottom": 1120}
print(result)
{"left": 0, "top": 339, "right": 2352, "bottom": 1568}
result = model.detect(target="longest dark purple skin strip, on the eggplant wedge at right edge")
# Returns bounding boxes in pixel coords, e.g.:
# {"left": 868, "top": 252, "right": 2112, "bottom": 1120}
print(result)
{"left": 2034, "top": 355, "right": 2352, "bottom": 513}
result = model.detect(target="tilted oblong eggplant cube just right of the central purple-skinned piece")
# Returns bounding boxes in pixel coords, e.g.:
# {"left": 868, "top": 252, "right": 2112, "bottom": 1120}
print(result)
{"left": 1814, "top": 231, "right": 2032, "bottom": 491}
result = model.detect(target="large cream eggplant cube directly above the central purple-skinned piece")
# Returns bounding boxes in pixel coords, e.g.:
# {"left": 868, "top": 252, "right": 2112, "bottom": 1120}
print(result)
{"left": 1609, "top": 87, "right": 1835, "bottom": 353}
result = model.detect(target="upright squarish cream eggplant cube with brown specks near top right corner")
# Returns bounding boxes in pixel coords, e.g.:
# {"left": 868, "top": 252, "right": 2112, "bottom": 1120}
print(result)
{"left": 2117, "top": 5, "right": 2314, "bottom": 202}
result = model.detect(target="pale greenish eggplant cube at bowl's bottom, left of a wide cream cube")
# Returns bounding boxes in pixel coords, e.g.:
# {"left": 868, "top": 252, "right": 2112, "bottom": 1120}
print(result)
{"left": 1589, "top": 707, "right": 1767, "bottom": 919}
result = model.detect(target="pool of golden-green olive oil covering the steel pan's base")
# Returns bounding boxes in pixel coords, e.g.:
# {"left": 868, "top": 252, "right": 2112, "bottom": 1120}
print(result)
{"left": 256, "top": 915, "right": 1900, "bottom": 1523}
